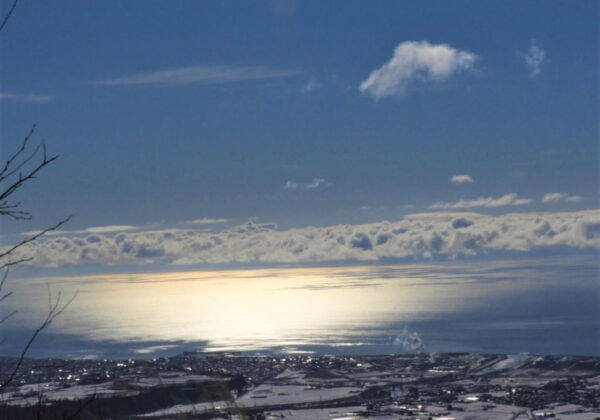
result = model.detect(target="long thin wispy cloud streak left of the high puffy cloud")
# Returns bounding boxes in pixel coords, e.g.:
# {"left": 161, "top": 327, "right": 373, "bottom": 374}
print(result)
{"left": 93, "top": 66, "right": 302, "bottom": 86}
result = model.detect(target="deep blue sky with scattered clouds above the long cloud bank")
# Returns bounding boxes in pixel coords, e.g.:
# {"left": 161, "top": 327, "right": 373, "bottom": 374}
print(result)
{"left": 0, "top": 1, "right": 599, "bottom": 270}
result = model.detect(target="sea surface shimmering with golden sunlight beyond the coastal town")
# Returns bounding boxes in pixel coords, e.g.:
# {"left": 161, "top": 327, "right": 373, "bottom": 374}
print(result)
{"left": 2, "top": 257, "right": 600, "bottom": 358}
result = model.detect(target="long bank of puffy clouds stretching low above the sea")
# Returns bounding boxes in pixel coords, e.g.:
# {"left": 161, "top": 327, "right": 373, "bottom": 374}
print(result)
{"left": 5, "top": 210, "right": 600, "bottom": 266}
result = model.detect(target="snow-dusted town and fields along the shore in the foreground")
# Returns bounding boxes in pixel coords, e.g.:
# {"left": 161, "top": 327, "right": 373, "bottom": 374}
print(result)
{"left": 0, "top": 353, "right": 600, "bottom": 420}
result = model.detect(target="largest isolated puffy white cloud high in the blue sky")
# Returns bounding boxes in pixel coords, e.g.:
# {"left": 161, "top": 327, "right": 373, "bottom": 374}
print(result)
{"left": 359, "top": 41, "right": 477, "bottom": 99}
